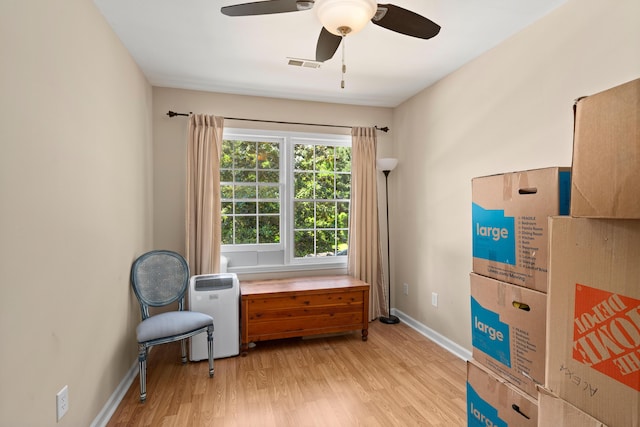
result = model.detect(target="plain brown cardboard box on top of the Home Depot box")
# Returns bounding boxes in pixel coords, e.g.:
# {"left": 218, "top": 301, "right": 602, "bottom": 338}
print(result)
{"left": 571, "top": 79, "right": 640, "bottom": 219}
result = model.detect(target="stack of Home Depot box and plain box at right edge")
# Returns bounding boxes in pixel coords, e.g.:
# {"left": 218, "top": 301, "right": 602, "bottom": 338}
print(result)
{"left": 540, "top": 79, "right": 640, "bottom": 427}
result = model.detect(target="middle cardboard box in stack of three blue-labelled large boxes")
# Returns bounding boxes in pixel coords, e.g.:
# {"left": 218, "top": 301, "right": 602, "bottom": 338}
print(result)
{"left": 471, "top": 273, "right": 547, "bottom": 398}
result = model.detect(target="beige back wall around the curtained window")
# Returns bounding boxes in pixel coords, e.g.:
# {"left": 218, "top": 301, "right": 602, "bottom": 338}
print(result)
{"left": 153, "top": 87, "right": 394, "bottom": 278}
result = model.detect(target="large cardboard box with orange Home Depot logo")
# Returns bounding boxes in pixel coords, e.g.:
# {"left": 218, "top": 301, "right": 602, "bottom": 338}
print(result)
{"left": 545, "top": 217, "right": 640, "bottom": 427}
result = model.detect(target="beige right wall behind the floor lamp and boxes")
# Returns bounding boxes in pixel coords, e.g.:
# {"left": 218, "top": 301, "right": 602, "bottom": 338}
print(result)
{"left": 390, "top": 0, "right": 640, "bottom": 349}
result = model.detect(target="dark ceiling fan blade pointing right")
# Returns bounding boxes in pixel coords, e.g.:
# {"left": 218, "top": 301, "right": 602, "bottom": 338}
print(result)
{"left": 371, "top": 4, "right": 440, "bottom": 39}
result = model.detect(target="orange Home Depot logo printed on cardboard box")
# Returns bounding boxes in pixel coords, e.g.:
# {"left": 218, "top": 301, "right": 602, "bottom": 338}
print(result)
{"left": 573, "top": 284, "right": 640, "bottom": 391}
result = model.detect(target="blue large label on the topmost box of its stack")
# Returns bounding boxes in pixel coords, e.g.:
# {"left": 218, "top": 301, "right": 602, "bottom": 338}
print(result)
{"left": 471, "top": 203, "right": 516, "bottom": 265}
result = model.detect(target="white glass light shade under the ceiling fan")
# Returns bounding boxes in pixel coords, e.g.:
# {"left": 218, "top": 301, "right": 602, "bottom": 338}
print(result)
{"left": 314, "top": 0, "right": 378, "bottom": 36}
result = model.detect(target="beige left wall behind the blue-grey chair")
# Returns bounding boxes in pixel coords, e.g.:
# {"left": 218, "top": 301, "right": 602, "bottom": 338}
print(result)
{"left": 0, "top": 0, "right": 153, "bottom": 426}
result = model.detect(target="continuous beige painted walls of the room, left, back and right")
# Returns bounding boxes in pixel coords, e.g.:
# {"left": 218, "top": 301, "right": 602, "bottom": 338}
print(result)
{"left": 0, "top": 0, "right": 640, "bottom": 426}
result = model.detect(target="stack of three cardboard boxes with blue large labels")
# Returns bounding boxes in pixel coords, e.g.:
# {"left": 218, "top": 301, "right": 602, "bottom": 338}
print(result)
{"left": 467, "top": 167, "right": 571, "bottom": 426}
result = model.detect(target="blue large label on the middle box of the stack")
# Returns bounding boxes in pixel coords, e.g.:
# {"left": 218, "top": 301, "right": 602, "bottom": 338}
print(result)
{"left": 471, "top": 297, "right": 511, "bottom": 368}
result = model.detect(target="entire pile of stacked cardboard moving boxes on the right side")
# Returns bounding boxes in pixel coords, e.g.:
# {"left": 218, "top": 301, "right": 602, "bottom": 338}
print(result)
{"left": 467, "top": 79, "right": 640, "bottom": 427}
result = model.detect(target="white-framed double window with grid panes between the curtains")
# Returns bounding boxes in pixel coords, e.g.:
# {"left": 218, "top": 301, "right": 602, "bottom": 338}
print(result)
{"left": 220, "top": 129, "right": 351, "bottom": 269}
